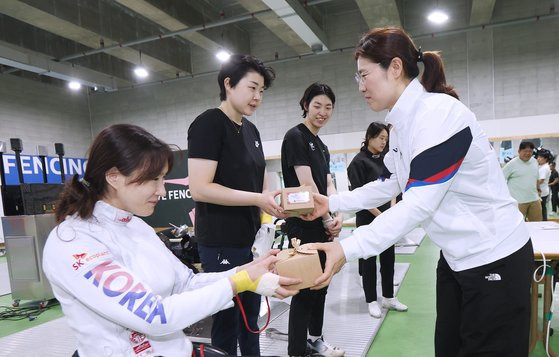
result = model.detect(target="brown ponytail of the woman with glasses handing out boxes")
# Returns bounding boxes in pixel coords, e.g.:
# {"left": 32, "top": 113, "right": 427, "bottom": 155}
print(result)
{"left": 418, "top": 49, "right": 460, "bottom": 99}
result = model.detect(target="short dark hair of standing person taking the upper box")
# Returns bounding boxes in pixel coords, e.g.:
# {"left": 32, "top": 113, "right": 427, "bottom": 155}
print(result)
{"left": 217, "top": 54, "right": 276, "bottom": 101}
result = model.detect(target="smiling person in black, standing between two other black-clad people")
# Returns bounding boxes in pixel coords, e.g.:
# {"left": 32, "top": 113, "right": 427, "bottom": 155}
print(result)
{"left": 281, "top": 83, "right": 345, "bottom": 356}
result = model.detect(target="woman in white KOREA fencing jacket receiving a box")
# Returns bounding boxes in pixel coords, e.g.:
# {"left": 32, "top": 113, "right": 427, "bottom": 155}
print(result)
{"left": 43, "top": 124, "right": 302, "bottom": 357}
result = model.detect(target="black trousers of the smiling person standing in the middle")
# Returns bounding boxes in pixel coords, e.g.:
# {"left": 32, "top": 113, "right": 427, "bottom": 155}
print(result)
{"left": 286, "top": 220, "right": 328, "bottom": 356}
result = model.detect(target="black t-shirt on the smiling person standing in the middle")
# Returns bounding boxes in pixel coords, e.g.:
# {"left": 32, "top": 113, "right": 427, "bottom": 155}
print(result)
{"left": 281, "top": 123, "right": 330, "bottom": 225}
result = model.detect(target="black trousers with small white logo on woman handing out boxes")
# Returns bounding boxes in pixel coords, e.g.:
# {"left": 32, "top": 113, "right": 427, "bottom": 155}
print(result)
{"left": 435, "top": 241, "right": 534, "bottom": 357}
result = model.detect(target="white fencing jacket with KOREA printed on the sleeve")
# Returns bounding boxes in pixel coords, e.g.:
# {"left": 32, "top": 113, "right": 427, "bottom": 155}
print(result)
{"left": 43, "top": 201, "right": 235, "bottom": 357}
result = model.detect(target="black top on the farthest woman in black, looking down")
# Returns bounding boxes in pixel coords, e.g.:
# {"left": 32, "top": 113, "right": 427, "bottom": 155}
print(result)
{"left": 347, "top": 149, "right": 391, "bottom": 227}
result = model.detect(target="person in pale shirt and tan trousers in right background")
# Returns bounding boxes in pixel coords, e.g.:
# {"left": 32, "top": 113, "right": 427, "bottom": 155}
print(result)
{"left": 503, "top": 141, "right": 542, "bottom": 222}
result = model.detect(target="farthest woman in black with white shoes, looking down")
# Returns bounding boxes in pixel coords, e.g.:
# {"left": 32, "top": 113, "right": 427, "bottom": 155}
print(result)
{"left": 347, "top": 122, "right": 408, "bottom": 319}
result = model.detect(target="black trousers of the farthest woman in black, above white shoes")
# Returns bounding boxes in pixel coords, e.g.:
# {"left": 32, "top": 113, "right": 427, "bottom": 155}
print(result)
{"left": 359, "top": 246, "right": 396, "bottom": 303}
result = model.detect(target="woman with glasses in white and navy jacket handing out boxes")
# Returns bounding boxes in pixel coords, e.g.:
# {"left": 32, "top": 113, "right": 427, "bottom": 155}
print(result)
{"left": 308, "top": 28, "right": 533, "bottom": 356}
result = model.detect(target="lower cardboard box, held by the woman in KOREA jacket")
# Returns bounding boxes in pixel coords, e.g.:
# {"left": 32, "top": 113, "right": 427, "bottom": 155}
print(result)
{"left": 276, "top": 242, "right": 322, "bottom": 290}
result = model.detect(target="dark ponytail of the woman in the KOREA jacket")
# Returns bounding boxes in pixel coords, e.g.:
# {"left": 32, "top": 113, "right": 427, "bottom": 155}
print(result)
{"left": 55, "top": 174, "right": 99, "bottom": 224}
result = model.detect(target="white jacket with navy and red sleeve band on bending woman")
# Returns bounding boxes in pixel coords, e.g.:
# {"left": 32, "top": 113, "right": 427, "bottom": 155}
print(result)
{"left": 329, "top": 79, "right": 529, "bottom": 271}
